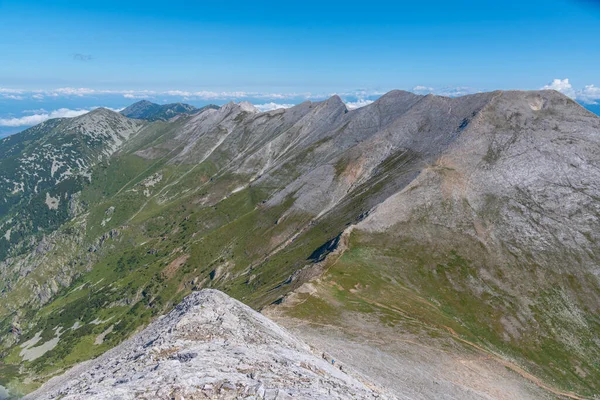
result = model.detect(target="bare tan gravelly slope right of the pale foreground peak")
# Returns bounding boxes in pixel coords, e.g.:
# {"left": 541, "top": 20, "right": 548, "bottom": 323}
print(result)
{"left": 266, "top": 294, "right": 566, "bottom": 400}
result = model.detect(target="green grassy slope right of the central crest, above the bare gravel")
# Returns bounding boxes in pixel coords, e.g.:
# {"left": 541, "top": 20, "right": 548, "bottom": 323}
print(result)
{"left": 280, "top": 227, "right": 600, "bottom": 398}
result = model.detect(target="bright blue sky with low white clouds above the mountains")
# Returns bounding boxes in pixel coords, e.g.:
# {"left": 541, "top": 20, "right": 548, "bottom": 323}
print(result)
{"left": 0, "top": 0, "right": 600, "bottom": 132}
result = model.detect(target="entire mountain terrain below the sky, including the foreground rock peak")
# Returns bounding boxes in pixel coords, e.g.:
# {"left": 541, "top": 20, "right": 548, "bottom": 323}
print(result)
{"left": 0, "top": 90, "right": 600, "bottom": 399}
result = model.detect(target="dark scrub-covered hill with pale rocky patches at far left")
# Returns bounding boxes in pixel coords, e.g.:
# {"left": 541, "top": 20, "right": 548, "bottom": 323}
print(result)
{"left": 0, "top": 108, "right": 145, "bottom": 259}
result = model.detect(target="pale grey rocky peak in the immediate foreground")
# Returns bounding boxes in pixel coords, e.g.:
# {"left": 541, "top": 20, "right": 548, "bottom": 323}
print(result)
{"left": 26, "top": 289, "right": 390, "bottom": 400}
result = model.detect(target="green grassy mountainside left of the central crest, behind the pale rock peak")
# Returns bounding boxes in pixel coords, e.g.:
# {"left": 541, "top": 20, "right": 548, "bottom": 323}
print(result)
{"left": 0, "top": 141, "right": 344, "bottom": 392}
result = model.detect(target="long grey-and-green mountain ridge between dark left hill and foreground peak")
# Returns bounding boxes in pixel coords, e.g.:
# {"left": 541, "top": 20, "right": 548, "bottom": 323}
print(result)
{"left": 0, "top": 91, "right": 600, "bottom": 395}
